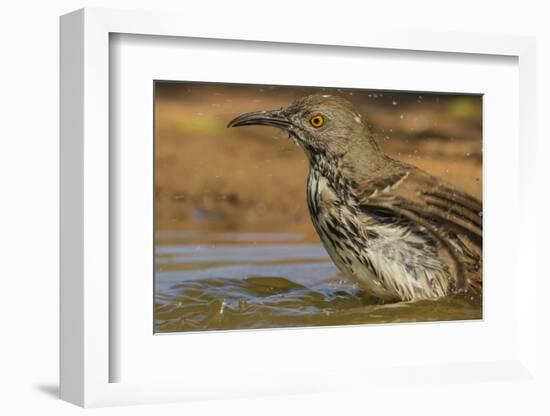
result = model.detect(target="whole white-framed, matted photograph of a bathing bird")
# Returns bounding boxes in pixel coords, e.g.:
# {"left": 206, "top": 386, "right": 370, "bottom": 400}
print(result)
{"left": 61, "top": 9, "right": 541, "bottom": 408}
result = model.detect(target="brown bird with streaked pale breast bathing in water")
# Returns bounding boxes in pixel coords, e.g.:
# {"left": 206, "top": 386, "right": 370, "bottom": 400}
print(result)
{"left": 228, "top": 94, "right": 483, "bottom": 302}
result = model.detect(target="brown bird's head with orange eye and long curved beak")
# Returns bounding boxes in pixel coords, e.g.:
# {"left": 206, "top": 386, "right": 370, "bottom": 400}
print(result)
{"left": 228, "top": 95, "right": 379, "bottom": 169}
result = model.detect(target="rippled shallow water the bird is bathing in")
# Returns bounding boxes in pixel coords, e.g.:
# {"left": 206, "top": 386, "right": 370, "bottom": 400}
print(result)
{"left": 155, "top": 231, "right": 482, "bottom": 332}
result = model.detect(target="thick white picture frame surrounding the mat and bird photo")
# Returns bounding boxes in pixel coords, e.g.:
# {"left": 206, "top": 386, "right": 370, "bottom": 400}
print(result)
{"left": 60, "top": 9, "right": 542, "bottom": 407}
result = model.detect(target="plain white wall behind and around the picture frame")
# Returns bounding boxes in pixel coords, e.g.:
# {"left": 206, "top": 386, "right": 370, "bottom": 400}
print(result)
{"left": 0, "top": 0, "right": 550, "bottom": 415}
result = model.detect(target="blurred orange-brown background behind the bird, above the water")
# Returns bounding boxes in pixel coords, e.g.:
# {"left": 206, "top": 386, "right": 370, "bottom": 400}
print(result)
{"left": 155, "top": 81, "right": 482, "bottom": 240}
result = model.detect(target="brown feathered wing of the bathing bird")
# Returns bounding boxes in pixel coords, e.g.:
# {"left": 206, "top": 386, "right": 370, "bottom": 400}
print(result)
{"left": 360, "top": 166, "right": 482, "bottom": 287}
